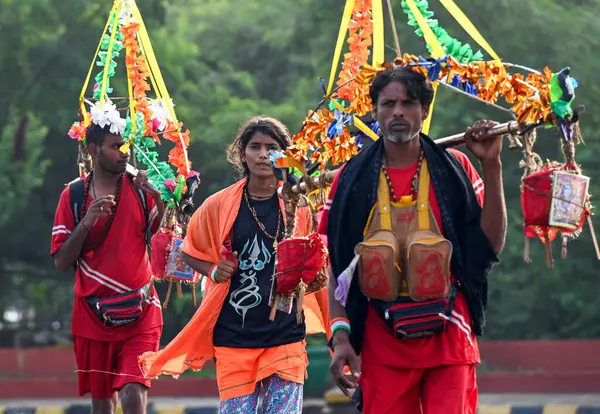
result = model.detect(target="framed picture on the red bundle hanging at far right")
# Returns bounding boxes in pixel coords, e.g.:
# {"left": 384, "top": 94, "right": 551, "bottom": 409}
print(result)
{"left": 549, "top": 171, "right": 590, "bottom": 230}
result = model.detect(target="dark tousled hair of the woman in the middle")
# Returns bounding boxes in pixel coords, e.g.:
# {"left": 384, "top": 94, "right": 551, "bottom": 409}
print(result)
{"left": 227, "top": 115, "right": 292, "bottom": 177}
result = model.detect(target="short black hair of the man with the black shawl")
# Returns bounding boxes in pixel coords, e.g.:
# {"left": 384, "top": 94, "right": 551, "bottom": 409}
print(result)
{"left": 369, "top": 66, "right": 433, "bottom": 108}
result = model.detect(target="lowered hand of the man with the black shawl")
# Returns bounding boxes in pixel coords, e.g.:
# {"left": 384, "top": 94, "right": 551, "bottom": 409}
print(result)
{"left": 329, "top": 331, "right": 360, "bottom": 398}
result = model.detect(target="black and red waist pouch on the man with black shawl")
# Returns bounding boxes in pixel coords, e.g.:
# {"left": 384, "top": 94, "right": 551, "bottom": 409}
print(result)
{"left": 373, "top": 286, "right": 456, "bottom": 339}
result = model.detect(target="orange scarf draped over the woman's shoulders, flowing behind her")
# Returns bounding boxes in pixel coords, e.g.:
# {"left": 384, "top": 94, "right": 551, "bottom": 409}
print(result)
{"left": 139, "top": 179, "right": 331, "bottom": 378}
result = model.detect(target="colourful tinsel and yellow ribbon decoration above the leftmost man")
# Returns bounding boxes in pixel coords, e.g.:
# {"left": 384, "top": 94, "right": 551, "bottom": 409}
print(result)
{"left": 68, "top": 0, "right": 198, "bottom": 202}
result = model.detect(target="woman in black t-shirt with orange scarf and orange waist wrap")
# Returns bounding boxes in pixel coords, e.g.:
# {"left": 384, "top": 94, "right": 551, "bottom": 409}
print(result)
{"left": 140, "top": 117, "right": 330, "bottom": 414}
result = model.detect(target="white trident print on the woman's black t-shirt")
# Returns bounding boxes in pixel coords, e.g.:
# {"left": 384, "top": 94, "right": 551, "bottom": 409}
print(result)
{"left": 229, "top": 234, "right": 273, "bottom": 327}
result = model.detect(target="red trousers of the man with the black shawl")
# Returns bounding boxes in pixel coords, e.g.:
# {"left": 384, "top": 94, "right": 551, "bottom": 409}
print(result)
{"left": 359, "top": 362, "right": 477, "bottom": 414}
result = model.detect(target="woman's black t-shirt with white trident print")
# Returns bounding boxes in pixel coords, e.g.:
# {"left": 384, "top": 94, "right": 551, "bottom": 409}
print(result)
{"left": 213, "top": 194, "right": 306, "bottom": 348}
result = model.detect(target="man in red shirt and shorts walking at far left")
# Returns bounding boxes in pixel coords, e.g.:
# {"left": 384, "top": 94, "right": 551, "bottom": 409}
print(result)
{"left": 51, "top": 123, "right": 164, "bottom": 414}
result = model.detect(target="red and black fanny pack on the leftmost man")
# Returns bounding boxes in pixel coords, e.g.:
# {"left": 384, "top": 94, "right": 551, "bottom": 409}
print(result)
{"left": 86, "top": 284, "right": 150, "bottom": 327}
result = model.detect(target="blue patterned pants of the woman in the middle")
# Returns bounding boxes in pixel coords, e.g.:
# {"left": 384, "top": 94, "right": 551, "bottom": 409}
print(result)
{"left": 219, "top": 375, "right": 303, "bottom": 414}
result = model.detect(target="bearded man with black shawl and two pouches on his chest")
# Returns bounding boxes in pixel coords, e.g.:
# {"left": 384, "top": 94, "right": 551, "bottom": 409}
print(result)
{"left": 320, "top": 66, "right": 506, "bottom": 414}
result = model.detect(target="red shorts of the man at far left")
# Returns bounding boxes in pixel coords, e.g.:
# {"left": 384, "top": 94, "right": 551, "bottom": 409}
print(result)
{"left": 73, "top": 327, "right": 161, "bottom": 398}
